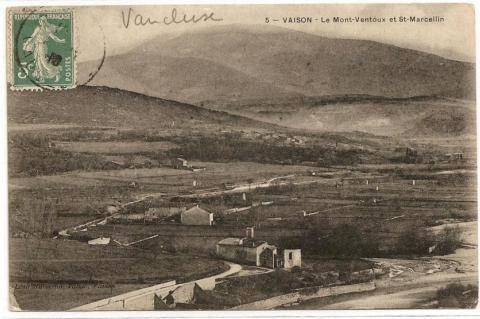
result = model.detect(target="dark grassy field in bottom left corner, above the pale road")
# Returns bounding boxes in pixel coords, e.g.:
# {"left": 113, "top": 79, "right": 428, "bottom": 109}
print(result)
{"left": 10, "top": 239, "right": 225, "bottom": 310}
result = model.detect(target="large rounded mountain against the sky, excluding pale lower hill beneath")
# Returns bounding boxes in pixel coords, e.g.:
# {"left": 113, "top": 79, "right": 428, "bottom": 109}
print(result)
{"left": 78, "top": 25, "right": 475, "bottom": 107}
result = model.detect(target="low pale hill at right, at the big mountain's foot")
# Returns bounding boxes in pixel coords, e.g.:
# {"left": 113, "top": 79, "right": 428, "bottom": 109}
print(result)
{"left": 218, "top": 95, "right": 476, "bottom": 137}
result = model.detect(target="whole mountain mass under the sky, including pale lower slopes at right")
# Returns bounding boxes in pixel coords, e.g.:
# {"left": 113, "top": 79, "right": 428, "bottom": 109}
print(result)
{"left": 73, "top": 25, "right": 475, "bottom": 135}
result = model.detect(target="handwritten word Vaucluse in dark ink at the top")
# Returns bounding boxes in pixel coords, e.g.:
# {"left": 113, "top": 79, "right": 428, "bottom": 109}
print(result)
{"left": 122, "top": 8, "right": 223, "bottom": 29}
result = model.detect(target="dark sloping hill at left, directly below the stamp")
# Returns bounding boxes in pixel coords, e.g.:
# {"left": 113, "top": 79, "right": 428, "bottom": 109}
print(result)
{"left": 7, "top": 86, "right": 272, "bottom": 129}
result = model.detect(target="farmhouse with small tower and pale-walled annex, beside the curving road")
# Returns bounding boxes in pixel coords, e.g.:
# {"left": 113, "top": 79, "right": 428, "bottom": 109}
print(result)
{"left": 216, "top": 227, "right": 302, "bottom": 269}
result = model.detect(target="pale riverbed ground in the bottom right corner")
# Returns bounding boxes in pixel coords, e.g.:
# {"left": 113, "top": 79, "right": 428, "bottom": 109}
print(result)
{"left": 293, "top": 248, "right": 478, "bottom": 309}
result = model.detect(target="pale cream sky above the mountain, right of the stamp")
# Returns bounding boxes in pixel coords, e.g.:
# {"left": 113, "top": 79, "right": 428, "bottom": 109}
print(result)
{"left": 75, "top": 3, "right": 475, "bottom": 62}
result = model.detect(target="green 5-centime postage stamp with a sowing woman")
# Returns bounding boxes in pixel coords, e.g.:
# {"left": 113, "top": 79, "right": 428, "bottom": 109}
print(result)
{"left": 8, "top": 9, "right": 76, "bottom": 89}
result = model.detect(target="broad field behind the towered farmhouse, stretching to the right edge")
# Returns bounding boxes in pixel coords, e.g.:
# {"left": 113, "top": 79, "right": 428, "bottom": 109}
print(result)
{"left": 41, "top": 163, "right": 476, "bottom": 253}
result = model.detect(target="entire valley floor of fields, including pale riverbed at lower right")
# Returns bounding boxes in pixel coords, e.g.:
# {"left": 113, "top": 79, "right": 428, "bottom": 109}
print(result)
{"left": 9, "top": 124, "right": 477, "bottom": 310}
